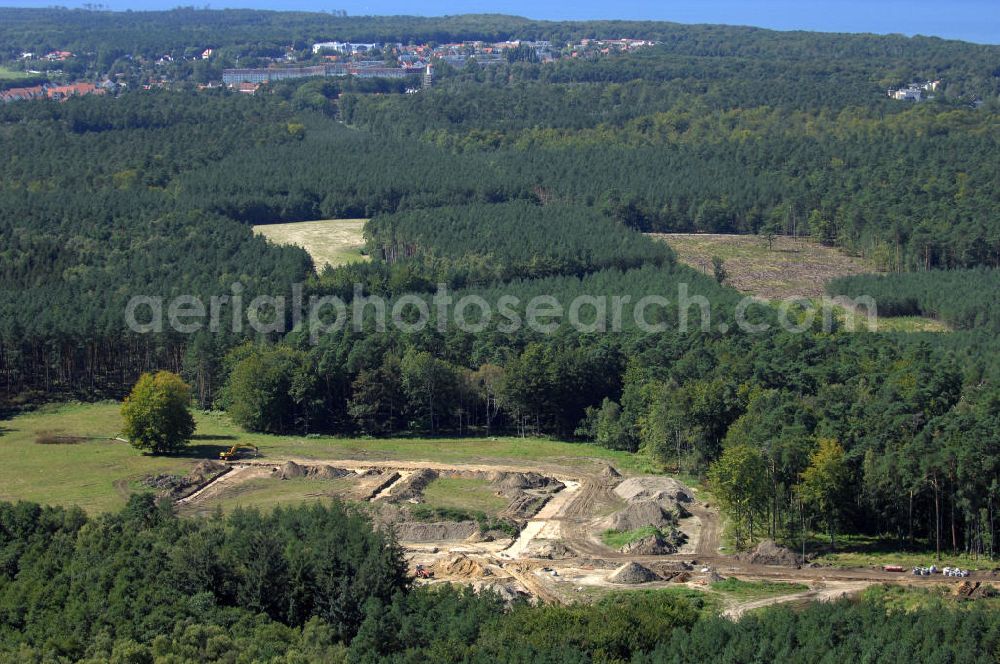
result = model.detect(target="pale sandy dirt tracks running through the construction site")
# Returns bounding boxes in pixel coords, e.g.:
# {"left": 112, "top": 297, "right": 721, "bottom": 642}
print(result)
{"left": 179, "top": 458, "right": 988, "bottom": 617}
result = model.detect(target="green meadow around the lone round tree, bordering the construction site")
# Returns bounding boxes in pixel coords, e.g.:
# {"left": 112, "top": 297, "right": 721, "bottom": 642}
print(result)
{"left": 0, "top": 403, "right": 643, "bottom": 513}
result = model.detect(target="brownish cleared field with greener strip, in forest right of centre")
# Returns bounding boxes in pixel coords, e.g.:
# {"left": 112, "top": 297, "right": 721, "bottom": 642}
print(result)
{"left": 653, "top": 233, "right": 950, "bottom": 332}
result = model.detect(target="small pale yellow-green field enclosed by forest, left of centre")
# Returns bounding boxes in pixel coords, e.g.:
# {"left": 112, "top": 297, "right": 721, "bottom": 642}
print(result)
{"left": 253, "top": 219, "right": 368, "bottom": 270}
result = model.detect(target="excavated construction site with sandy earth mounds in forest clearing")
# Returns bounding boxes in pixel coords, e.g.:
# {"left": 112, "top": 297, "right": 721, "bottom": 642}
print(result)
{"left": 156, "top": 450, "right": 995, "bottom": 617}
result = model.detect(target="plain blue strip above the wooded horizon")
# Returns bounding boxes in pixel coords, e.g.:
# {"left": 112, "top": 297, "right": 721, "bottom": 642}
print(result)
{"left": 7, "top": 0, "right": 1000, "bottom": 44}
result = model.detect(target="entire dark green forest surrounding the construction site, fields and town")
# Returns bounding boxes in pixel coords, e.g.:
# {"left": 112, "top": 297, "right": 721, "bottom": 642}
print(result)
{"left": 0, "top": 9, "right": 1000, "bottom": 662}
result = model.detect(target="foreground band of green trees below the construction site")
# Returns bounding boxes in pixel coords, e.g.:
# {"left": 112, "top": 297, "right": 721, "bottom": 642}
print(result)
{"left": 0, "top": 496, "right": 1000, "bottom": 664}
